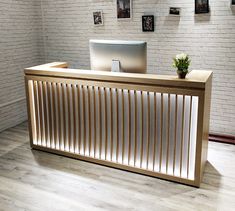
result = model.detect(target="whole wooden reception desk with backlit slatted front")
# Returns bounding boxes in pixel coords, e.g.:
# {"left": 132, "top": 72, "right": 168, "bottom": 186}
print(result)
{"left": 25, "top": 62, "right": 212, "bottom": 187}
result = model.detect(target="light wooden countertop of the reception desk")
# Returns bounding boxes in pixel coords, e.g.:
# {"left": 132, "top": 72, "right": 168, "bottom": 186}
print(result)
{"left": 25, "top": 62, "right": 213, "bottom": 89}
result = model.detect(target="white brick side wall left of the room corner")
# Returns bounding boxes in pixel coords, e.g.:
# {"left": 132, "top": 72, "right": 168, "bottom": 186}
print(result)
{"left": 0, "top": 0, "right": 44, "bottom": 131}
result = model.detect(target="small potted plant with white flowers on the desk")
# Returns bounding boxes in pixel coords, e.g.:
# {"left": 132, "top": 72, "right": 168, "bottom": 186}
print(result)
{"left": 173, "top": 53, "right": 191, "bottom": 79}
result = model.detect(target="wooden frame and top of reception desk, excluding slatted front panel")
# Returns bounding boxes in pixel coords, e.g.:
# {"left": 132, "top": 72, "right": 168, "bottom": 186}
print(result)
{"left": 25, "top": 62, "right": 212, "bottom": 187}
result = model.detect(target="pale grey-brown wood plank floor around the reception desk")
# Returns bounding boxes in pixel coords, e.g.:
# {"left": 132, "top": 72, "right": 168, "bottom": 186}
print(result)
{"left": 0, "top": 123, "right": 235, "bottom": 211}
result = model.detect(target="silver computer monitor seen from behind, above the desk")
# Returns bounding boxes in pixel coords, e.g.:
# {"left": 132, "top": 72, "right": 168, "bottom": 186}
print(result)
{"left": 90, "top": 40, "right": 147, "bottom": 73}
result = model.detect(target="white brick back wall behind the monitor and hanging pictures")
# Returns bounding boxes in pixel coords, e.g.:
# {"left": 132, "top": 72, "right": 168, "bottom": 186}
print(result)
{"left": 42, "top": 0, "right": 235, "bottom": 135}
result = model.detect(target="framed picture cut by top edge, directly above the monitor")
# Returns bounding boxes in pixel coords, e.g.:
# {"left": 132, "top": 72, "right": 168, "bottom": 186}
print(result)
{"left": 116, "top": 0, "right": 132, "bottom": 20}
